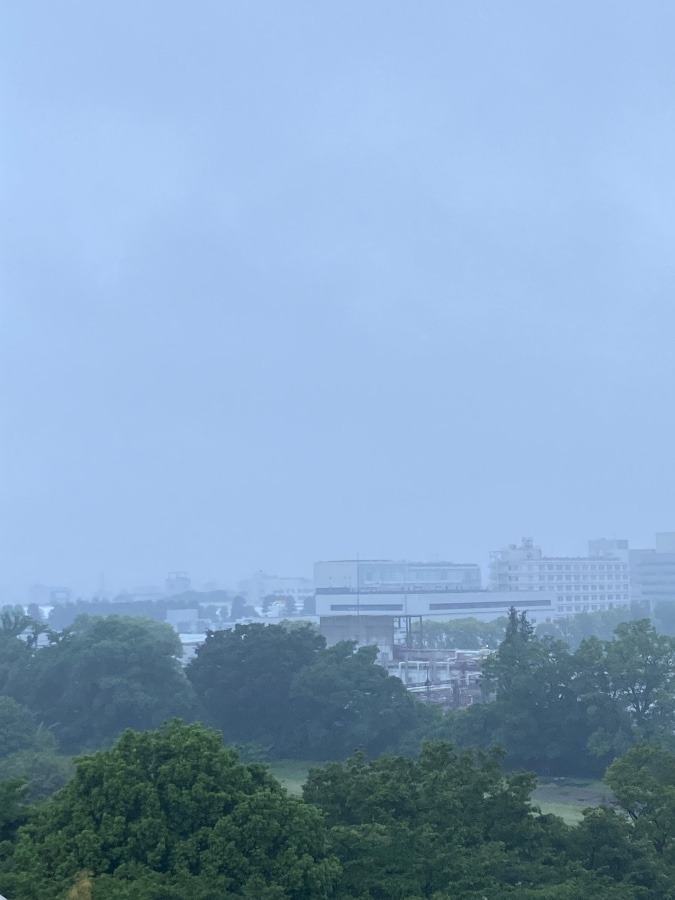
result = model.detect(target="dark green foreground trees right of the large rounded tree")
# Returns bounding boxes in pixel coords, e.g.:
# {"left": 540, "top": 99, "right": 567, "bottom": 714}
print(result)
{"left": 304, "top": 742, "right": 639, "bottom": 900}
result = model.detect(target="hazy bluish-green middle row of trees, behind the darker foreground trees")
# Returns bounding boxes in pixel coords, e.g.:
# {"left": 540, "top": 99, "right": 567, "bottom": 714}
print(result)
{"left": 0, "top": 610, "right": 675, "bottom": 784}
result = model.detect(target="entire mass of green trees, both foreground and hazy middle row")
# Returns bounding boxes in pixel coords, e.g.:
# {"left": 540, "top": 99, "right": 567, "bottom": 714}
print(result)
{"left": 0, "top": 610, "right": 675, "bottom": 900}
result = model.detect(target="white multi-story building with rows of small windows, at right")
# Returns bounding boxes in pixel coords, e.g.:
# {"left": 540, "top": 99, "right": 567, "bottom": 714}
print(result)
{"left": 490, "top": 538, "right": 631, "bottom": 615}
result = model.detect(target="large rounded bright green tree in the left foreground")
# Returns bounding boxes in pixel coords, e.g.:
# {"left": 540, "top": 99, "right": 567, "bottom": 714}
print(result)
{"left": 2, "top": 721, "right": 339, "bottom": 900}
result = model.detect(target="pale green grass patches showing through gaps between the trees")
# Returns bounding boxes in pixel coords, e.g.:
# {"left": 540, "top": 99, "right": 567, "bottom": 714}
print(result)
{"left": 269, "top": 759, "right": 612, "bottom": 825}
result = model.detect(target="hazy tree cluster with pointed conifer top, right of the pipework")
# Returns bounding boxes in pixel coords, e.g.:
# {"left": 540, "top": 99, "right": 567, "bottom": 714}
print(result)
{"left": 437, "top": 610, "right": 675, "bottom": 775}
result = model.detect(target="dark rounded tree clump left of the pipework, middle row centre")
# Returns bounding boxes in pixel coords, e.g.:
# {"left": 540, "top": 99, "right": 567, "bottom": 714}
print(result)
{"left": 187, "top": 624, "right": 424, "bottom": 759}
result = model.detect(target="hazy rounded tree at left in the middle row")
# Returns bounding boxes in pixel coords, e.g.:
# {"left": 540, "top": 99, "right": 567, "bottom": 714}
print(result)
{"left": 14, "top": 616, "right": 196, "bottom": 752}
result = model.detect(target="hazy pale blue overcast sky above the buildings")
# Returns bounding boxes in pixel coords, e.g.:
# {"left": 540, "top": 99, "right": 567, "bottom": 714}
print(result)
{"left": 0, "top": 0, "right": 675, "bottom": 601}
